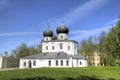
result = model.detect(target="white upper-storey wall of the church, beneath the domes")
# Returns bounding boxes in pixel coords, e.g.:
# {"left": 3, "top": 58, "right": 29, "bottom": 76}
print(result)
{"left": 42, "top": 41, "right": 77, "bottom": 55}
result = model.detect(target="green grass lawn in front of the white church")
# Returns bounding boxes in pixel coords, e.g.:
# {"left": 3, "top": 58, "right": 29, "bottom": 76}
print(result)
{"left": 0, "top": 67, "right": 120, "bottom": 80}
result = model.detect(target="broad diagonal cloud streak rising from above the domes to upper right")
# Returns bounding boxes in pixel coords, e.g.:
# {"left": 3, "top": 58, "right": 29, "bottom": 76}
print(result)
{"left": 39, "top": 0, "right": 111, "bottom": 29}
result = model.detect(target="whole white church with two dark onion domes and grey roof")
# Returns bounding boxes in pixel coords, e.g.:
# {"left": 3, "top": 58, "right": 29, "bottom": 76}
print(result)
{"left": 19, "top": 23, "right": 87, "bottom": 68}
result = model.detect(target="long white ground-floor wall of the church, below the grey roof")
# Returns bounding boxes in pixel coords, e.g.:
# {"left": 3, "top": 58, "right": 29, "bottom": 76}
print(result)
{"left": 19, "top": 58, "right": 87, "bottom": 68}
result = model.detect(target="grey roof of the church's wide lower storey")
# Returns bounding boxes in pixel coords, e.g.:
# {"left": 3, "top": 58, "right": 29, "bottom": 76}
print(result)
{"left": 21, "top": 52, "right": 85, "bottom": 59}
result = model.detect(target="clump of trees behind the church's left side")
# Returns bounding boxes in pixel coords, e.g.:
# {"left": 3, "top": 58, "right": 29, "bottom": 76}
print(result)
{"left": 9, "top": 43, "right": 42, "bottom": 67}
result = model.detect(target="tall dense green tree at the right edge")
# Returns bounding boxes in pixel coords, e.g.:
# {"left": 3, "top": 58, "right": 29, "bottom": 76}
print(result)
{"left": 106, "top": 20, "right": 120, "bottom": 59}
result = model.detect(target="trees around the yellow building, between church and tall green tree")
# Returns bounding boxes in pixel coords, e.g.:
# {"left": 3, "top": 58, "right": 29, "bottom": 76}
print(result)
{"left": 79, "top": 31, "right": 115, "bottom": 65}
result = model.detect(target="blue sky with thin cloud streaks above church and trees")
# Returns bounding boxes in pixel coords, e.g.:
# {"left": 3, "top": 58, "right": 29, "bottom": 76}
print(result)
{"left": 0, "top": 0, "right": 120, "bottom": 53}
